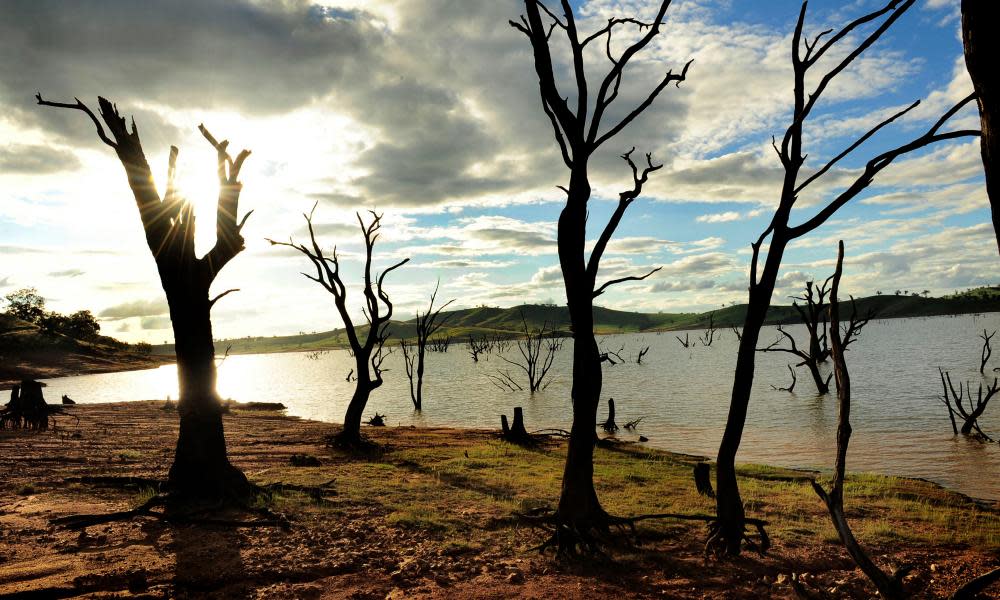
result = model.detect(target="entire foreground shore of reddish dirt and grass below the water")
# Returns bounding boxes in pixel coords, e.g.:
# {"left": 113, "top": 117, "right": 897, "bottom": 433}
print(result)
{"left": 0, "top": 401, "right": 1000, "bottom": 600}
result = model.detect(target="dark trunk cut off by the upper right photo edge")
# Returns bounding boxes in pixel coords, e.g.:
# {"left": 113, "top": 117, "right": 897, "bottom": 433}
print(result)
{"left": 962, "top": 0, "right": 1000, "bottom": 250}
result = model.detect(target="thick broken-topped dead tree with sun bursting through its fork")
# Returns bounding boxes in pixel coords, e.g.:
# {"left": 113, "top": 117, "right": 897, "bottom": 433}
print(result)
{"left": 36, "top": 94, "right": 253, "bottom": 496}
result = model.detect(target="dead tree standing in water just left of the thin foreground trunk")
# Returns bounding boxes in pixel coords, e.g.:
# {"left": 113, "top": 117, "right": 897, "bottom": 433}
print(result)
{"left": 758, "top": 278, "right": 833, "bottom": 394}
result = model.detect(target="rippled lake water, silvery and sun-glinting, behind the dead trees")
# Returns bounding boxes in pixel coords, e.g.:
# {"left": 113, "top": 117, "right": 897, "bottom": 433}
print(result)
{"left": 37, "top": 313, "right": 1000, "bottom": 499}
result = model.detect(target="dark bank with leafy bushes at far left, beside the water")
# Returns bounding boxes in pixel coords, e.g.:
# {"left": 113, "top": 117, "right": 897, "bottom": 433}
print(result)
{"left": 0, "top": 313, "right": 172, "bottom": 392}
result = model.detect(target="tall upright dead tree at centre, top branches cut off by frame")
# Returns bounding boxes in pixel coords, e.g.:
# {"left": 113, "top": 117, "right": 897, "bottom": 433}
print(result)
{"left": 510, "top": 0, "right": 690, "bottom": 553}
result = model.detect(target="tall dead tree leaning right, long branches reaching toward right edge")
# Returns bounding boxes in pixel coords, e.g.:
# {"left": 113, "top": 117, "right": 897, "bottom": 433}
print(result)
{"left": 711, "top": 0, "right": 979, "bottom": 555}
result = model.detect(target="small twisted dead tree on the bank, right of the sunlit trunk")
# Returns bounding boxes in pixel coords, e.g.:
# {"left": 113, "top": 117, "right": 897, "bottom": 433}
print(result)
{"left": 268, "top": 203, "right": 410, "bottom": 447}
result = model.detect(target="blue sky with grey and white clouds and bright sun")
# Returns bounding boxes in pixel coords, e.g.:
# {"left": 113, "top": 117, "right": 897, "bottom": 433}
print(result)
{"left": 0, "top": 0, "right": 1000, "bottom": 343}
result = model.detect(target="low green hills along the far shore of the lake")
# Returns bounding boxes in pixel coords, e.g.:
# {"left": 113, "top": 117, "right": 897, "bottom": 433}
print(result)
{"left": 153, "top": 287, "right": 1000, "bottom": 355}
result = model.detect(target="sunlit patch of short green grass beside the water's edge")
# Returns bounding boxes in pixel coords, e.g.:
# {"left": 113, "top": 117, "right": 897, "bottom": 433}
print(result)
{"left": 256, "top": 429, "right": 1000, "bottom": 551}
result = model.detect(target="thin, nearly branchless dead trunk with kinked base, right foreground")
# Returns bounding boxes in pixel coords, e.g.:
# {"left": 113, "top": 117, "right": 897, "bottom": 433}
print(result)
{"left": 812, "top": 241, "right": 909, "bottom": 599}
